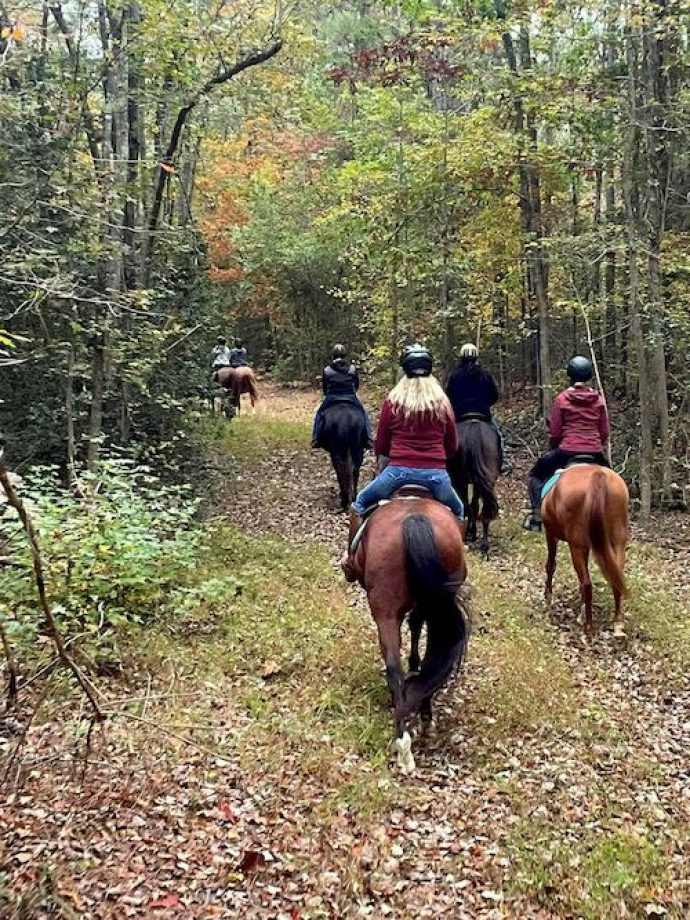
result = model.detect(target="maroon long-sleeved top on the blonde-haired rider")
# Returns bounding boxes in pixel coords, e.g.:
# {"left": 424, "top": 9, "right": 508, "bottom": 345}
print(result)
{"left": 375, "top": 400, "right": 458, "bottom": 470}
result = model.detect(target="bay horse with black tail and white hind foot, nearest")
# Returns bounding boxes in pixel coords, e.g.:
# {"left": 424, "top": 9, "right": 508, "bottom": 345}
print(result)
{"left": 343, "top": 489, "right": 468, "bottom": 773}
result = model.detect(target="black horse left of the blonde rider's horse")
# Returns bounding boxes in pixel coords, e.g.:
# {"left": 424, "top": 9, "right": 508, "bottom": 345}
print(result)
{"left": 320, "top": 400, "right": 367, "bottom": 511}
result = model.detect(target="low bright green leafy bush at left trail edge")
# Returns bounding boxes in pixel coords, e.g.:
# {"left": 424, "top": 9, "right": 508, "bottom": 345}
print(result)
{"left": 0, "top": 461, "right": 202, "bottom": 651}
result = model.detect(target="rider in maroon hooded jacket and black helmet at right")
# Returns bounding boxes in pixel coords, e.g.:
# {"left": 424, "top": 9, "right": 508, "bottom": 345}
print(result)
{"left": 522, "top": 355, "right": 609, "bottom": 530}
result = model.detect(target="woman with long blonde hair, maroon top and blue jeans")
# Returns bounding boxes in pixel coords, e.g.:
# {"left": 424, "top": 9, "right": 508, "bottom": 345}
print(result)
{"left": 344, "top": 343, "right": 465, "bottom": 526}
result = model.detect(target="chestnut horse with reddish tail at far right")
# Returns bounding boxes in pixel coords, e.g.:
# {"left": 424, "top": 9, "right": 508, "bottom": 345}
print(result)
{"left": 542, "top": 463, "right": 630, "bottom": 638}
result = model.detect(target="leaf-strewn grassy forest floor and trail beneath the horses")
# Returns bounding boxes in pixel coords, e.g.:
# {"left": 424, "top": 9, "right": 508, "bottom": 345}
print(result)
{"left": 0, "top": 385, "right": 690, "bottom": 920}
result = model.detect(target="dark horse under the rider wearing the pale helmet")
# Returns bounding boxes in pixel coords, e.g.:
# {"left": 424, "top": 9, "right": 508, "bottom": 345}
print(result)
{"left": 448, "top": 418, "right": 501, "bottom": 558}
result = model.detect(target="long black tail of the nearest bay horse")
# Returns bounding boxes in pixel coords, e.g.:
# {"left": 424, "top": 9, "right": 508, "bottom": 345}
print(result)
{"left": 403, "top": 514, "right": 467, "bottom": 712}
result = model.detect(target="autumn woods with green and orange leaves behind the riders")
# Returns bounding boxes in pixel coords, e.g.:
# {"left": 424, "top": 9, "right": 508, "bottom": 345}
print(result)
{"left": 0, "top": 0, "right": 690, "bottom": 516}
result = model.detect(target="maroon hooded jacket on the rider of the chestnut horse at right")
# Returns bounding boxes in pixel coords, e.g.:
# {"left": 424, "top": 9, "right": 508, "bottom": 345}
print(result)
{"left": 549, "top": 386, "right": 609, "bottom": 454}
